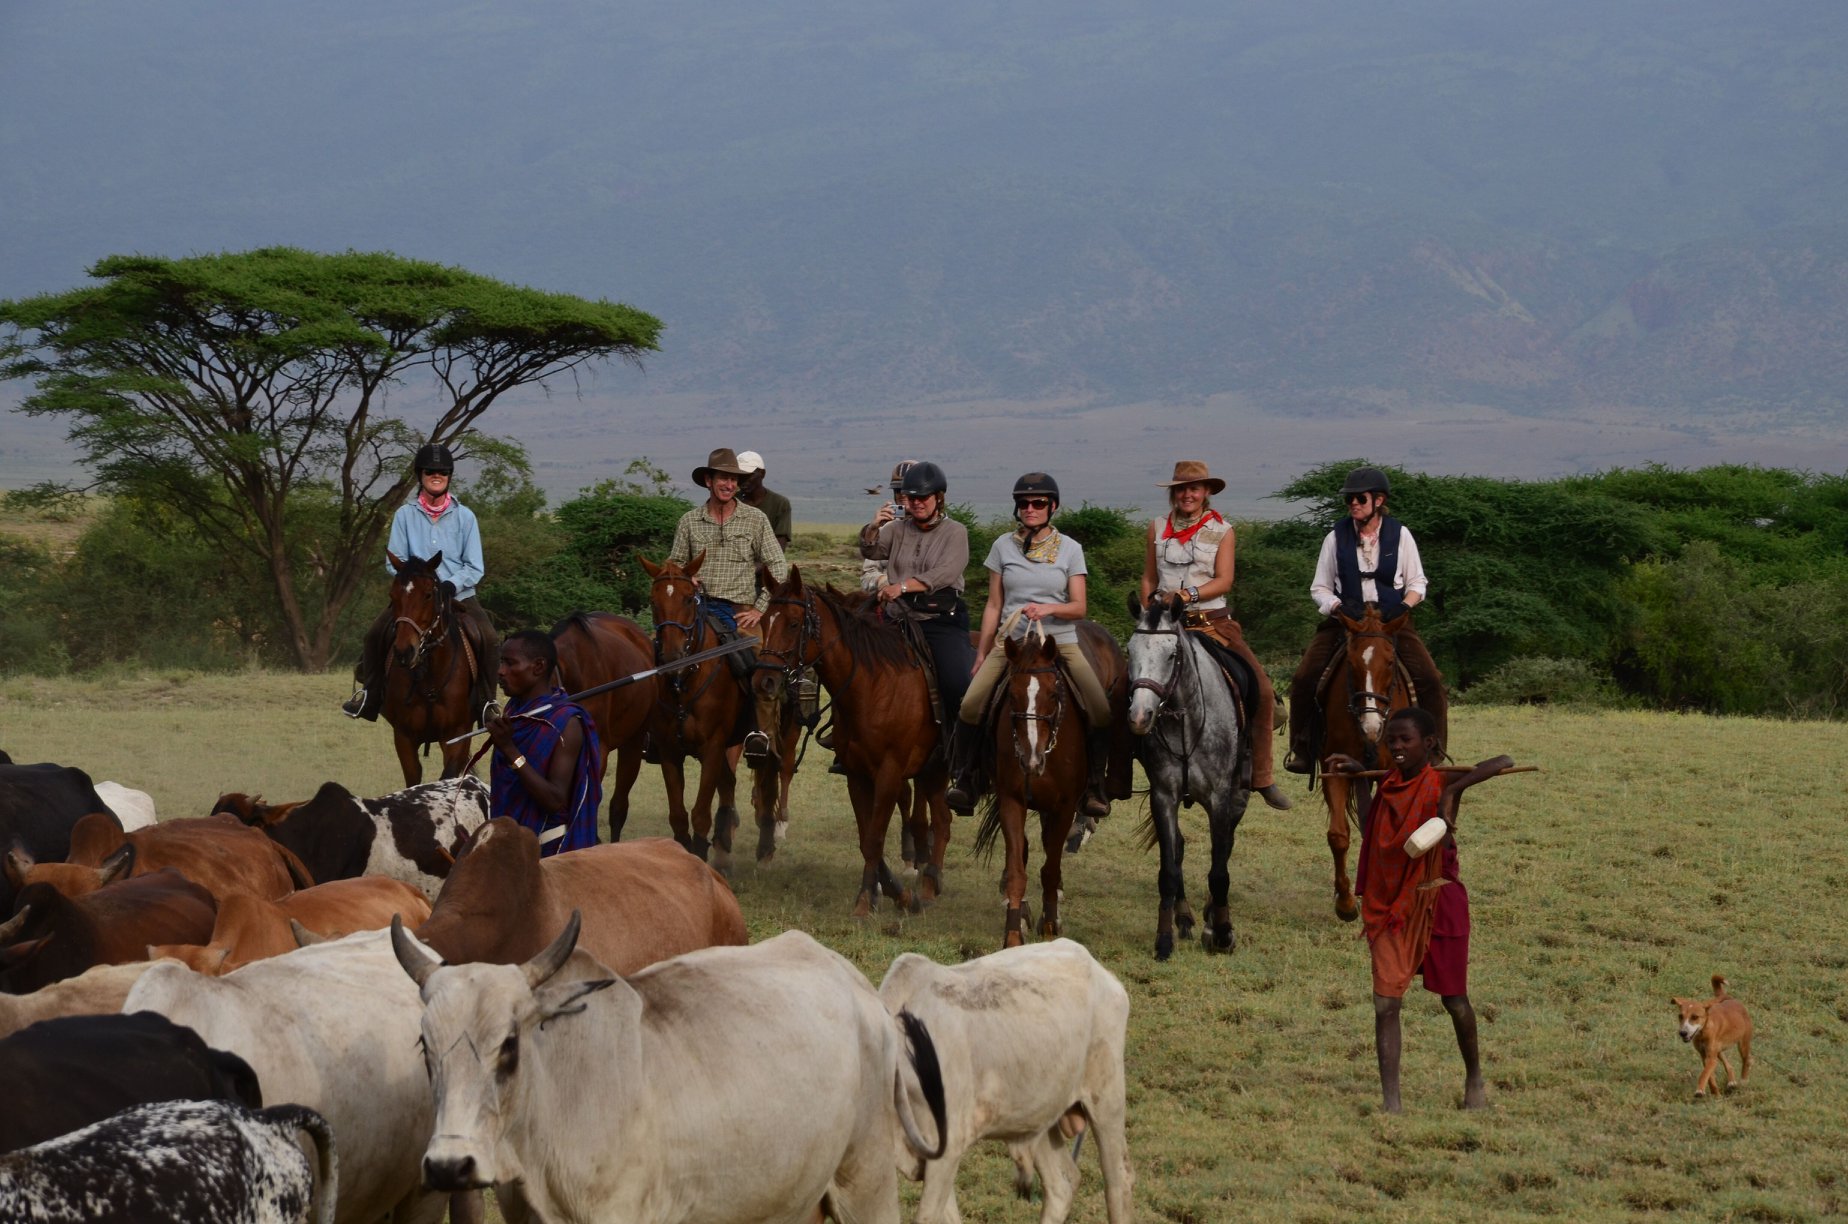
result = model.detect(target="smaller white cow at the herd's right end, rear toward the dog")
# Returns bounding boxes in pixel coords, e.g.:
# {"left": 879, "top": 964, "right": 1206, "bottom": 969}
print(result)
{"left": 880, "top": 939, "right": 1135, "bottom": 1224}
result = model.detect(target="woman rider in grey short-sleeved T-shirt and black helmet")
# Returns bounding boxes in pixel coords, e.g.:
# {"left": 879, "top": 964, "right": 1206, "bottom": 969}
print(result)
{"left": 948, "top": 471, "right": 1111, "bottom": 817}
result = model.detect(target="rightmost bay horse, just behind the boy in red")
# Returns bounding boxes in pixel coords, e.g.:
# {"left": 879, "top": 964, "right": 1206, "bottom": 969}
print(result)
{"left": 1312, "top": 603, "right": 1412, "bottom": 923}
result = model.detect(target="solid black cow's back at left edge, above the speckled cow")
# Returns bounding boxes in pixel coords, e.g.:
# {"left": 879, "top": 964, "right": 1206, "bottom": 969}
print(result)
{"left": 0, "top": 1011, "right": 262, "bottom": 1152}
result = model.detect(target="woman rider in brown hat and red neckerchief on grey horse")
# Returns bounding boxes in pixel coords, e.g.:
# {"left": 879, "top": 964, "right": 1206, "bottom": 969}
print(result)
{"left": 1142, "top": 459, "right": 1290, "bottom": 808}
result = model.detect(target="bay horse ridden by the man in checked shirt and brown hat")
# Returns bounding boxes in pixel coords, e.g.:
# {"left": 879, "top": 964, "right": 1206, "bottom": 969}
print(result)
{"left": 639, "top": 551, "right": 754, "bottom": 876}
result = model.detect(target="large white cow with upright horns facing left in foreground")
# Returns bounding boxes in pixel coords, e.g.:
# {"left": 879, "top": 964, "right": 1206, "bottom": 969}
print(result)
{"left": 392, "top": 915, "right": 944, "bottom": 1224}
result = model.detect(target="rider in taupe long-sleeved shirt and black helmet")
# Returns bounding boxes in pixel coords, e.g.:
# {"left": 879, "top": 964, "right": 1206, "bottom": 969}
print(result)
{"left": 859, "top": 462, "right": 976, "bottom": 787}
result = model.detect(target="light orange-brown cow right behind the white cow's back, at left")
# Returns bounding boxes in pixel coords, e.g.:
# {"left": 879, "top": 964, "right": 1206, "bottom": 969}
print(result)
{"left": 148, "top": 876, "right": 431, "bottom": 976}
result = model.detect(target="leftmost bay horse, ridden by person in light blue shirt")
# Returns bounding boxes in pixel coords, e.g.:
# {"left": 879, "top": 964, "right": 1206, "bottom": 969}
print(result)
{"left": 381, "top": 551, "right": 499, "bottom": 786}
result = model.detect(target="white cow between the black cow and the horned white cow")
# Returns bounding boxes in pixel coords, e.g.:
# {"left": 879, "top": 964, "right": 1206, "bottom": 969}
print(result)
{"left": 122, "top": 930, "right": 447, "bottom": 1224}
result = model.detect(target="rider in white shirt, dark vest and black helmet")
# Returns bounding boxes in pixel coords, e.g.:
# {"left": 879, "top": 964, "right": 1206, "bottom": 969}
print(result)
{"left": 1283, "top": 468, "right": 1449, "bottom": 773}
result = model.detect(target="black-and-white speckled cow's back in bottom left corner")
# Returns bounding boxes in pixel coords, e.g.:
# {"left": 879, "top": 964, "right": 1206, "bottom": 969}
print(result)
{"left": 0, "top": 1100, "right": 338, "bottom": 1224}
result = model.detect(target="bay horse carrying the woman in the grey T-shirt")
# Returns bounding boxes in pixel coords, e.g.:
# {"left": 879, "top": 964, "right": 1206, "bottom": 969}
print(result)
{"left": 976, "top": 621, "right": 1129, "bottom": 949}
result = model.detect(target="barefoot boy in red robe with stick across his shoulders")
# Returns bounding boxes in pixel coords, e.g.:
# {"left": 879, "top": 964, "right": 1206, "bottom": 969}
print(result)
{"left": 1329, "top": 708, "right": 1514, "bottom": 1113}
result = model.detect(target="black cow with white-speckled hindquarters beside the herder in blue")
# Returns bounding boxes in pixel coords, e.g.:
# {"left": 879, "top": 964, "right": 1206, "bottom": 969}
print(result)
{"left": 213, "top": 775, "right": 488, "bottom": 900}
